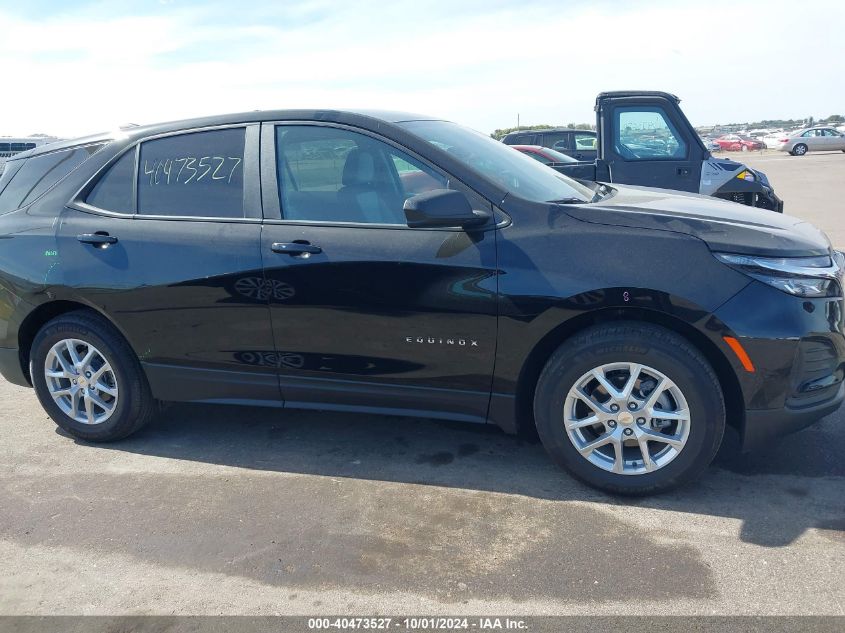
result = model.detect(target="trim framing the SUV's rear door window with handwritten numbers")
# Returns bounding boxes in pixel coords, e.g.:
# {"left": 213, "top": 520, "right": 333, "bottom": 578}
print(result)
{"left": 68, "top": 121, "right": 262, "bottom": 223}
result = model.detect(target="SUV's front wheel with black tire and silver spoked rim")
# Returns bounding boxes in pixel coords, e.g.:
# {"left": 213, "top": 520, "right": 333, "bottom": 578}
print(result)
{"left": 534, "top": 322, "right": 725, "bottom": 495}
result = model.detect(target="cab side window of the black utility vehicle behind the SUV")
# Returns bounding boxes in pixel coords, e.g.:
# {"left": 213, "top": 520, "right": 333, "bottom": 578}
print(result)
{"left": 614, "top": 106, "right": 687, "bottom": 160}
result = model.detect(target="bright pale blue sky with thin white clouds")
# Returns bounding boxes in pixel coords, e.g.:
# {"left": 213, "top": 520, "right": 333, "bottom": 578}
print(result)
{"left": 0, "top": 0, "right": 845, "bottom": 137}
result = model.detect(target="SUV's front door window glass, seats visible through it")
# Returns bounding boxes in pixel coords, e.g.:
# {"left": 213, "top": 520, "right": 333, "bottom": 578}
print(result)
{"left": 276, "top": 125, "right": 448, "bottom": 225}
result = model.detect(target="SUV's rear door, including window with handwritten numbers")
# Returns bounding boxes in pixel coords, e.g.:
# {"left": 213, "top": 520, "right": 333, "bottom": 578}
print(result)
{"left": 58, "top": 124, "right": 281, "bottom": 405}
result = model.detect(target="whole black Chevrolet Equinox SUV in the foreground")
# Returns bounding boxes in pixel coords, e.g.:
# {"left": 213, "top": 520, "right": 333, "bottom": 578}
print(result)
{"left": 0, "top": 110, "right": 845, "bottom": 493}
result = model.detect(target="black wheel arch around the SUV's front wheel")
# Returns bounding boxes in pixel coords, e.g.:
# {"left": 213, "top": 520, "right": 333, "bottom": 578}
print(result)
{"left": 516, "top": 308, "right": 745, "bottom": 436}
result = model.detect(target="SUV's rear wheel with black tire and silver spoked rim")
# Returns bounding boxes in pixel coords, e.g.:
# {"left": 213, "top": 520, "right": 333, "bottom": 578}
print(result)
{"left": 29, "top": 311, "right": 156, "bottom": 442}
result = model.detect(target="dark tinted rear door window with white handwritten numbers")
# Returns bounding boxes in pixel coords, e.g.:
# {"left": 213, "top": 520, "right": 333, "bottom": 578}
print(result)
{"left": 135, "top": 128, "right": 245, "bottom": 218}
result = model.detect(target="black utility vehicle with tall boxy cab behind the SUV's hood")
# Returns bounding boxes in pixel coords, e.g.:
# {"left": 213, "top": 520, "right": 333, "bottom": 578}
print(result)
{"left": 503, "top": 90, "right": 783, "bottom": 213}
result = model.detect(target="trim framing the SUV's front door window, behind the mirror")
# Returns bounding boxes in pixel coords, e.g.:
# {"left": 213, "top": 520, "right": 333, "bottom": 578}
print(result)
{"left": 261, "top": 119, "right": 498, "bottom": 233}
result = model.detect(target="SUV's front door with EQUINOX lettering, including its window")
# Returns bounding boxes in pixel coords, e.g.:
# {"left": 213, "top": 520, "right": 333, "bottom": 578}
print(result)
{"left": 261, "top": 124, "right": 496, "bottom": 421}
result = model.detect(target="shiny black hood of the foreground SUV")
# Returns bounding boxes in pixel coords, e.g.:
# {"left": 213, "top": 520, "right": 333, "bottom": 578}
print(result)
{"left": 565, "top": 184, "right": 831, "bottom": 257}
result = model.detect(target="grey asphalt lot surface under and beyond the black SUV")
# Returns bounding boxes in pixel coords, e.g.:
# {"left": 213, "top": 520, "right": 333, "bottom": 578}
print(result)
{"left": 0, "top": 153, "right": 845, "bottom": 615}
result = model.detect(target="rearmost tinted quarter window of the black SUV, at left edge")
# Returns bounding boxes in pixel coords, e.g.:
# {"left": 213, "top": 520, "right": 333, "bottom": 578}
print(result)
{"left": 0, "top": 145, "right": 103, "bottom": 213}
